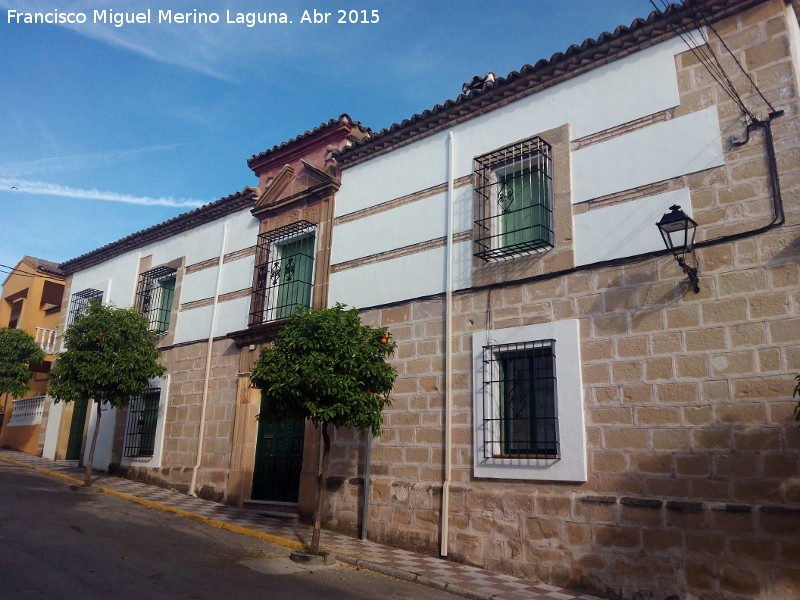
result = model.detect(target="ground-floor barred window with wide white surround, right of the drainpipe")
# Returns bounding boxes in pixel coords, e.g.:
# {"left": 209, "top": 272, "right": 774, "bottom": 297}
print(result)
{"left": 472, "top": 320, "right": 586, "bottom": 481}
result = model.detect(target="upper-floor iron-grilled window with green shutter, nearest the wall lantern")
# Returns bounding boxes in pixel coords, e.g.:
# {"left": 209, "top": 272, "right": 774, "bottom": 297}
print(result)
{"left": 473, "top": 137, "right": 553, "bottom": 260}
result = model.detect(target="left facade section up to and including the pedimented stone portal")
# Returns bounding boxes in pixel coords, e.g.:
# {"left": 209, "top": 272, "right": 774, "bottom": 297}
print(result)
{"left": 44, "top": 115, "right": 367, "bottom": 512}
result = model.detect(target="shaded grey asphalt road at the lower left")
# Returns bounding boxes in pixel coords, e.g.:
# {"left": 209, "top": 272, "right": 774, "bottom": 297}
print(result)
{"left": 0, "top": 462, "right": 459, "bottom": 600}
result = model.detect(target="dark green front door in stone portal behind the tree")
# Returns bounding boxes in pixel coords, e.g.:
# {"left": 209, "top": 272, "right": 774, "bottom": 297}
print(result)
{"left": 252, "top": 396, "right": 305, "bottom": 502}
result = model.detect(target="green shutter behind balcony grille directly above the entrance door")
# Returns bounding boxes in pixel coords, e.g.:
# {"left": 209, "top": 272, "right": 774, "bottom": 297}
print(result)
{"left": 275, "top": 235, "right": 314, "bottom": 319}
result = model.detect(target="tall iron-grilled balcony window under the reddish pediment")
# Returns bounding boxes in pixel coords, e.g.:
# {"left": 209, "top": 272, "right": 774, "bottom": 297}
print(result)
{"left": 250, "top": 221, "right": 317, "bottom": 325}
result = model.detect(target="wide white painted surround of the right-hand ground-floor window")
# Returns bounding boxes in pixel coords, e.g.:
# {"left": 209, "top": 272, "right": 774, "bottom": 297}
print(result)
{"left": 472, "top": 319, "right": 587, "bottom": 482}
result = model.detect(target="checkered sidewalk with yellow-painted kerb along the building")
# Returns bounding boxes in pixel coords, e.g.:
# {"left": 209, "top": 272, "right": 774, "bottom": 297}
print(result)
{"left": 0, "top": 448, "right": 602, "bottom": 600}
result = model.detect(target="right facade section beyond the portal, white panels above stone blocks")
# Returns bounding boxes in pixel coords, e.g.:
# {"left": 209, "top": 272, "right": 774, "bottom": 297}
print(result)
{"left": 327, "top": 0, "right": 800, "bottom": 600}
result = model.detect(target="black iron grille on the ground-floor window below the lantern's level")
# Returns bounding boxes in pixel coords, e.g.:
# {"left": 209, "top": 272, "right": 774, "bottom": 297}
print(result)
{"left": 483, "top": 340, "right": 561, "bottom": 459}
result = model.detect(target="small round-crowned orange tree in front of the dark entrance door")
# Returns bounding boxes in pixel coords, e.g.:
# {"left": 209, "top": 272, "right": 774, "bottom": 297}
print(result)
{"left": 251, "top": 304, "right": 397, "bottom": 553}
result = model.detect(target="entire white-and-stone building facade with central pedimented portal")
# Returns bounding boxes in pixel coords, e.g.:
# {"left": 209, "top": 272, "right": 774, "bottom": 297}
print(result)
{"left": 17, "top": 0, "right": 800, "bottom": 600}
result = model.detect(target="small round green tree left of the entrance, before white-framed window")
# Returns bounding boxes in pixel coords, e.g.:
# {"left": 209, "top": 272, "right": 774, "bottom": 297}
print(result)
{"left": 47, "top": 300, "right": 166, "bottom": 486}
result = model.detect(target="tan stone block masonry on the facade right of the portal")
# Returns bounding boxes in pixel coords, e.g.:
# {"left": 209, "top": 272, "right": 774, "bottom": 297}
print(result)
{"left": 327, "top": 1, "right": 800, "bottom": 600}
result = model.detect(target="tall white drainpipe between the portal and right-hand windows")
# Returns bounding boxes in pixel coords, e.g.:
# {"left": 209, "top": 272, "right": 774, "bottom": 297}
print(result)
{"left": 440, "top": 131, "right": 455, "bottom": 556}
